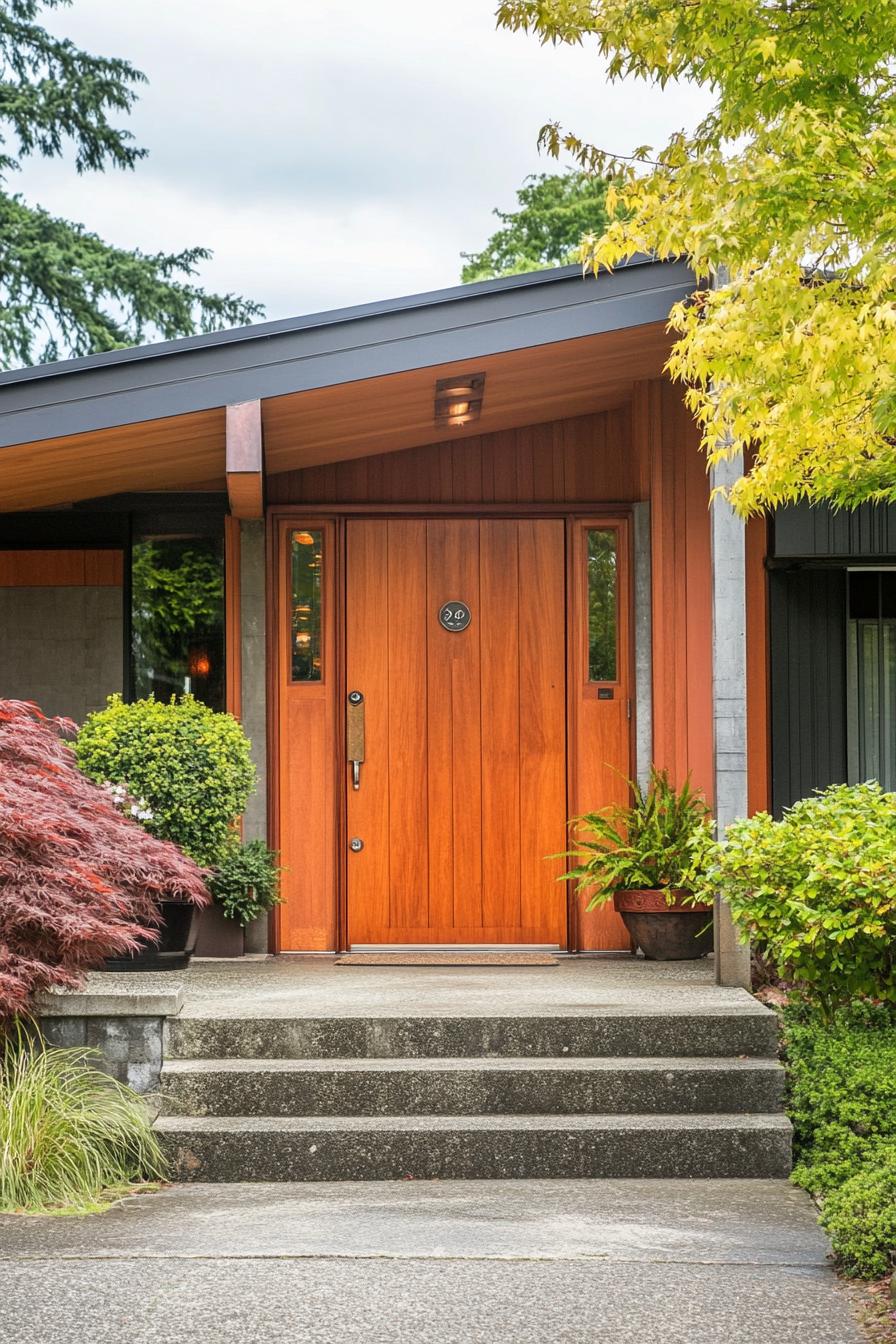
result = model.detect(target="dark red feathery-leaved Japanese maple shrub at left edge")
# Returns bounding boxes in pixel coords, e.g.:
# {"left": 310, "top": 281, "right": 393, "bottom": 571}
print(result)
{"left": 0, "top": 700, "right": 208, "bottom": 1015}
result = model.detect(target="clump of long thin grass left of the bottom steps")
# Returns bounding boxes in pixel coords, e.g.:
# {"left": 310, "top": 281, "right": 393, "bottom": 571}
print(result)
{"left": 0, "top": 1028, "right": 164, "bottom": 1214}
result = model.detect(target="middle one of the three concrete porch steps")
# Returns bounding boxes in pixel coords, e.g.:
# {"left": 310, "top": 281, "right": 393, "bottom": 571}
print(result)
{"left": 161, "top": 1056, "right": 785, "bottom": 1117}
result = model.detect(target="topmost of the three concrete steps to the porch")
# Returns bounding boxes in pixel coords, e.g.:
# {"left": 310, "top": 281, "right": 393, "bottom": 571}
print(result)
{"left": 165, "top": 1001, "right": 778, "bottom": 1059}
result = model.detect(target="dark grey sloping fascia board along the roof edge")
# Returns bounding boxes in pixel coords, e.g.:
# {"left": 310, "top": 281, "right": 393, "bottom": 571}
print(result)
{"left": 0, "top": 257, "right": 695, "bottom": 446}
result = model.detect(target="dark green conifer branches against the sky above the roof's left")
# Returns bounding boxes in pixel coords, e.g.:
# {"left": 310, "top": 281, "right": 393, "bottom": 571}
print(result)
{"left": 0, "top": 0, "right": 261, "bottom": 368}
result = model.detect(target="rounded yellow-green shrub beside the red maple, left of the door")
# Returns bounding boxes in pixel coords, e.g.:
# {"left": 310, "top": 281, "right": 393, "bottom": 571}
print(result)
{"left": 75, "top": 695, "right": 255, "bottom": 867}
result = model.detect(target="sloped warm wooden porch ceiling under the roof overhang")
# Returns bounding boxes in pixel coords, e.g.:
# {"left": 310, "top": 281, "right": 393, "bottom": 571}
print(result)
{"left": 0, "top": 323, "right": 670, "bottom": 512}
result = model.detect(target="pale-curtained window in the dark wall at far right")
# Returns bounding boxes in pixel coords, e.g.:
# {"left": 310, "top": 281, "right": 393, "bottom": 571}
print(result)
{"left": 846, "top": 570, "right": 896, "bottom": 789}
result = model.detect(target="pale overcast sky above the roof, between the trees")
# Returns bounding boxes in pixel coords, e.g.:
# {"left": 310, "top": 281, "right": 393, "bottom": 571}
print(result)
{"left": 15, "top": 0, "right": 704, "bottom": 317}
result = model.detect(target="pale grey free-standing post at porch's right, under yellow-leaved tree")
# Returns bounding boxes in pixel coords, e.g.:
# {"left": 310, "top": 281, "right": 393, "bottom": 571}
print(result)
{"left": 709, "top": 454, "right": 750, "bottom": 989}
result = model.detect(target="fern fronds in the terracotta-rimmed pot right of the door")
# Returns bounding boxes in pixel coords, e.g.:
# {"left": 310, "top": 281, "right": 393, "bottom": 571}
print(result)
{"left": 563, "top": 767, "right": 712, "bottom": 910}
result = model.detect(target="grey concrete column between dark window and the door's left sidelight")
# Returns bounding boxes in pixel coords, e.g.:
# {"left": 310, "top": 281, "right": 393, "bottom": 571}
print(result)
{"left": 239, "top": 519, "right": 267, "bottom": 953}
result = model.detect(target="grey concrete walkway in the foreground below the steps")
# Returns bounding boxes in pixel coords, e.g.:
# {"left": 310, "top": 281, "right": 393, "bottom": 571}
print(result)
{"left": 0, "top": 1180, "right": 864, "bottom": 1344}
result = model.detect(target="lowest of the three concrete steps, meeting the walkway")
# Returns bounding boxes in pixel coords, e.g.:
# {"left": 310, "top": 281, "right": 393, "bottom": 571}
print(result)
{"left": 156, "top": 1116, "right": 790, "bottom": 1181}
